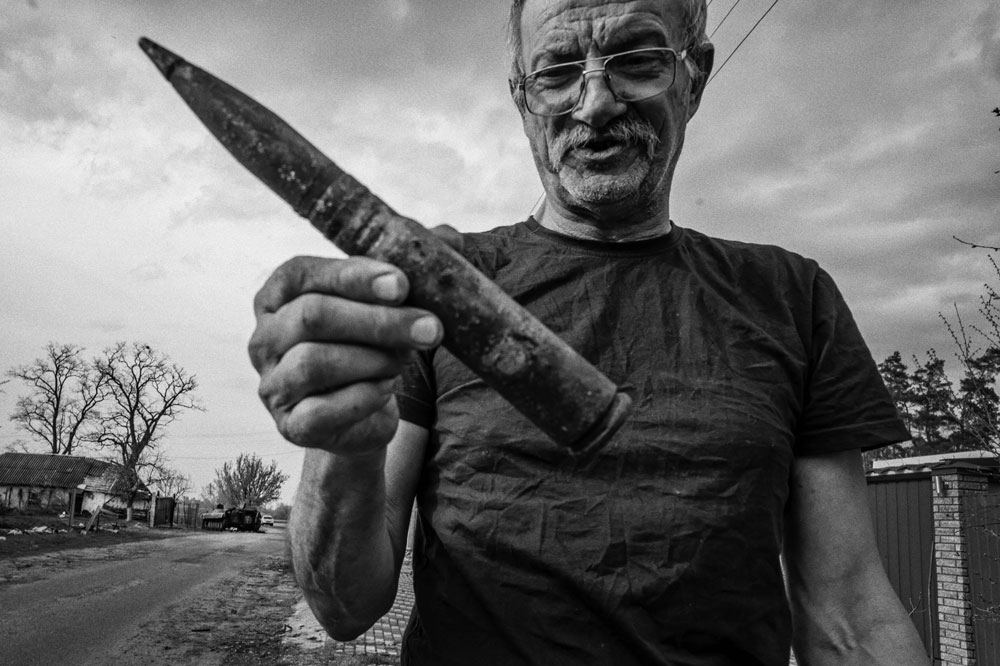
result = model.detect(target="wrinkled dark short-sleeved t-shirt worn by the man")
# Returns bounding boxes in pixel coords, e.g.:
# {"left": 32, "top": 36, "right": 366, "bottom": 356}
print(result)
{"left": 398, "top": 219, "right": 908, "bottom": 666}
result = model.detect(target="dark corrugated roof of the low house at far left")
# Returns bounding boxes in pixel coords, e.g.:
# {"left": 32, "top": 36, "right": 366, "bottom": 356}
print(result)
{"left": 0, "top": 453, "right": 146, "bottom": 494}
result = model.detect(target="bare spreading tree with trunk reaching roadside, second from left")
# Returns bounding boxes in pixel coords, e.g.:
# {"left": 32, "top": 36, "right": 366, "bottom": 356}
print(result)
{"left": 95, "top": 342, "right": 201, "bottom": 520}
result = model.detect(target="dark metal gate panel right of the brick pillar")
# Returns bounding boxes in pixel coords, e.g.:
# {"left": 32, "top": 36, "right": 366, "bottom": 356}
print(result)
{"left": 963, "top": 494, "right": 1000, "bottom": 664}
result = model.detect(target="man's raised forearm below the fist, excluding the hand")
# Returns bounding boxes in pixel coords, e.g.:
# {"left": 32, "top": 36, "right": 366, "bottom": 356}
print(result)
{"left": 290, "top": 449, "right": 402, "bottom": 640}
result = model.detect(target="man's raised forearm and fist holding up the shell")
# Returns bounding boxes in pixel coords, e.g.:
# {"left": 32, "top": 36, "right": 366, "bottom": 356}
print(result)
{"left": 249, "top": 257, "right": 442, "bottom": 639}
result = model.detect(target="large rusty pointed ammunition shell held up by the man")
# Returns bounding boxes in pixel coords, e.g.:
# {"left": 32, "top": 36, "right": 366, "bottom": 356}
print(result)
{"left": 139, "top": 38, "right": 631, "bottom": 452}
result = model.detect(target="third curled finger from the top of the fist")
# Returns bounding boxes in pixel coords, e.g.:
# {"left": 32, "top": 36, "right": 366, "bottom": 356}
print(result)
{"left": 258, "top": 343, "right": 405, "bottom": 414}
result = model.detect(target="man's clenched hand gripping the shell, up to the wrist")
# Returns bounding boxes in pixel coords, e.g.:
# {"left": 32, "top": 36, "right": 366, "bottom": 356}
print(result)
{"left": 249, "top": 252, "right": 443, "bottom": 455}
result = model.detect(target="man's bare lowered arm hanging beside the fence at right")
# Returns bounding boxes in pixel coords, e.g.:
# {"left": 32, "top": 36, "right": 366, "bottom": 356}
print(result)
{"left": 784, "top": 450, "right": 929, "bottom": 666}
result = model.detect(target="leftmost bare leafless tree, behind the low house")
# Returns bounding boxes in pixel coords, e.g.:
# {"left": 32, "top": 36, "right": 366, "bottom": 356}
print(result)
{"left": 7, "top": 342, "right": 106, "bottom": 455}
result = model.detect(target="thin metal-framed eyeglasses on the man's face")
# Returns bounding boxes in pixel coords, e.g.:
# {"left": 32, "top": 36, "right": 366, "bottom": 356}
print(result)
{"left": 511, "top": 47, "right": 687, "bottom": 116}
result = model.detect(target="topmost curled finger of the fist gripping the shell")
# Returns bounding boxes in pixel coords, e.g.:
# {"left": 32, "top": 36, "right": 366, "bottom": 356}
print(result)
{"left": 254, "top": 257, "right": 410, "bottom": 317}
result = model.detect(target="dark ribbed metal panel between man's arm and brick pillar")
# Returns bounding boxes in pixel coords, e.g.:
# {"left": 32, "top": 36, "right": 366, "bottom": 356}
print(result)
{"left": 868, "top": 474, "right": 936, "bottom": 664}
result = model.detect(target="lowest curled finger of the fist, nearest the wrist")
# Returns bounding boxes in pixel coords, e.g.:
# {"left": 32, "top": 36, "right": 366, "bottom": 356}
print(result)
{"left": 276, "top": 382, "right": 399, "bottom": 454}
